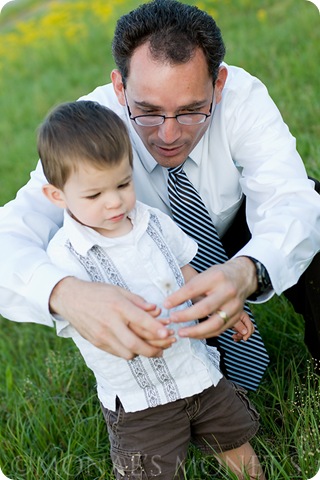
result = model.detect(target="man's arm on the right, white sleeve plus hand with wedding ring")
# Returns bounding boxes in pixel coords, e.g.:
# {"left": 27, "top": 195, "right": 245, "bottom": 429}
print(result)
{"left": 165, "top": 69, "right": 320, "bottom": 338}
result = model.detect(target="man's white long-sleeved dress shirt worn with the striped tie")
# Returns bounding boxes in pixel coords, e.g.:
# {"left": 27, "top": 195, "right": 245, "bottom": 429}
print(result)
{"left": 0, "top": 66, "right": 320, "bottom": 325}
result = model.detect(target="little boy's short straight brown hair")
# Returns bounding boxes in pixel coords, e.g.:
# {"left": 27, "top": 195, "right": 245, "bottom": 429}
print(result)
{"left": 37, "top": 101, "right": 133, "bottom": 189}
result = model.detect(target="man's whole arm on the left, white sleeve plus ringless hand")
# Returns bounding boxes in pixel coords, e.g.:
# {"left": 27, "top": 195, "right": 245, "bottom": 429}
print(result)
{"left": 0, "top": 164, "right": 168, "bottom": 358}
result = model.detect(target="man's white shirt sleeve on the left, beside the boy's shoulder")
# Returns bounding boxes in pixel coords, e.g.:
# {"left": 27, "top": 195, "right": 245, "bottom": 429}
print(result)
{"left": 0, "top": 163, "right": 64, "bottom": 326}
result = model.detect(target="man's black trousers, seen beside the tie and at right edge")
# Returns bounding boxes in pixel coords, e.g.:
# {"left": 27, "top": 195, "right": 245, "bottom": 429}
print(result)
{"left": 222, "top": 179, "right": 320, "bottom": 361}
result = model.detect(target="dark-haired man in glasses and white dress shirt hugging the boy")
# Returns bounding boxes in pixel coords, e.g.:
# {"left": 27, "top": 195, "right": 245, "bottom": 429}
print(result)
{"left": 0, "top": 0, "right": 320, "bottom": 382}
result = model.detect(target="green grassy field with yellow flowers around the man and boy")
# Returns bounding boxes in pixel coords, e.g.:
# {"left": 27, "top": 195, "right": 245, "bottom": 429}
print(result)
{"left": 0, "top": 0, "right": 320, "bottom": 480}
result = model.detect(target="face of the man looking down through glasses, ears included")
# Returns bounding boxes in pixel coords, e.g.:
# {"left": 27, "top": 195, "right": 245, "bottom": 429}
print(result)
{"left": 112, "top": 44, "right": 225, "bottom": 171}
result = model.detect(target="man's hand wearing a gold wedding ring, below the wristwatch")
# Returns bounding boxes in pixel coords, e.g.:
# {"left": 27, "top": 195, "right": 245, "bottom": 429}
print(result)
{"left": 164, "top": 257, "right": 257, "bottom": 338}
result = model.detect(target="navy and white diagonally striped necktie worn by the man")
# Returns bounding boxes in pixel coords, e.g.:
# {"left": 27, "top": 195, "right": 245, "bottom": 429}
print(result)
{"left": 168, "top": 165, "right": 269, "bottom": 390}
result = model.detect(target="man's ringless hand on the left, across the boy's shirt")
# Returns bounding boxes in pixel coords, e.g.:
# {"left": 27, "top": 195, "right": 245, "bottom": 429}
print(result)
{"left": 50, "top": 277, "right": 174, "bottom": 360}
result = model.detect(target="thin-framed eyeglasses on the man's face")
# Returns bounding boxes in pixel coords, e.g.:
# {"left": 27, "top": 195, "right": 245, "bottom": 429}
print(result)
{"left": 124, "top": 91, "right": 214, "bottom": 127}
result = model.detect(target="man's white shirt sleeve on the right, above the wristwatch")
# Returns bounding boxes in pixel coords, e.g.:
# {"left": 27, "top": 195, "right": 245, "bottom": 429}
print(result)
{"left": 227, "top": 71, "right": 320, "bottom": 294}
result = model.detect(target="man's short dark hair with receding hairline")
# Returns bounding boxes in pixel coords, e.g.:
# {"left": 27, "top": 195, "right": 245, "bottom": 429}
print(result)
{"left": 112, "top": 0, "right": 225, "bottom": 86}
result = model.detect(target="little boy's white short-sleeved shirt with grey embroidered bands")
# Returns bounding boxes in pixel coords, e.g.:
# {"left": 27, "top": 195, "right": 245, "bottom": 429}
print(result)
{"left": 48, "top": 202, "right": 222, "bottom": 412}
